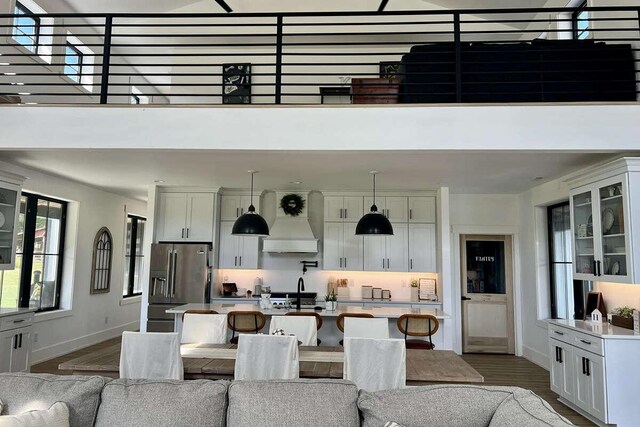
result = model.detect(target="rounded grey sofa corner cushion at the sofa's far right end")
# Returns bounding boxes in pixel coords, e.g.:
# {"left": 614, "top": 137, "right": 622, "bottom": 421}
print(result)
{"left": 489, "top": 389, "right": 573, "bottom": 427}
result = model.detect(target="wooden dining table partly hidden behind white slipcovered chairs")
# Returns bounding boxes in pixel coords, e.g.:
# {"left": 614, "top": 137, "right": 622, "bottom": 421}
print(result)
{"left": 58, "top": 344, "right": 484, "bottom": 385}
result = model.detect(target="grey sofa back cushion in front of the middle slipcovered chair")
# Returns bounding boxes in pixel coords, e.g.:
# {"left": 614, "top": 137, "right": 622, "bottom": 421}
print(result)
{"left": 227, "top": 379, "right": 360, "bottom": 427}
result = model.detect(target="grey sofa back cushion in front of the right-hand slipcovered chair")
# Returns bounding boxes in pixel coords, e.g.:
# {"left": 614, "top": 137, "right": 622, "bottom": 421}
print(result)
{"left": 358, "top": 385, "right": 520, "bottom": 427}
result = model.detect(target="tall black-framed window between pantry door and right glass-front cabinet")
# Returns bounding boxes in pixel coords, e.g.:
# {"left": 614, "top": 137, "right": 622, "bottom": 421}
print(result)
{"left": 547, "top": 202, "right": 591, "bottom": 319}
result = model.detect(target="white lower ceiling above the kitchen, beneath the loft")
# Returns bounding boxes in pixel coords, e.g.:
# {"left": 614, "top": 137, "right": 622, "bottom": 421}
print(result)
{"left": 0, "top": 150, "right": 614, "bottom": 199}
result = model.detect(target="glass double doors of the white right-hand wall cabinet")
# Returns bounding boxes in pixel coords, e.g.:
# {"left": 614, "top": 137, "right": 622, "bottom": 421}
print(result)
{"left": 571, "top": 167, "right": 637, "bottom": 283}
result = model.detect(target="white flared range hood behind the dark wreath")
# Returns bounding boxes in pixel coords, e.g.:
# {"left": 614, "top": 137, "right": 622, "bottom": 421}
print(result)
{"left": 262, "top": 191, "right": 318, "bottom": 253}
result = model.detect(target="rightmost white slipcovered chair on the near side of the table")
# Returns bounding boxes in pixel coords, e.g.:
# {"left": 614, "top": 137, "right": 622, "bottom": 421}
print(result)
{"left": 342, "top": 338, "right": 407, "bottom": 392}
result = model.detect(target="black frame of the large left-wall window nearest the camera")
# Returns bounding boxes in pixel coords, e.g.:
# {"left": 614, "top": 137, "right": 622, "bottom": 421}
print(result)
{"left": 18, "top": 191, "right": 68, "bottom": 313}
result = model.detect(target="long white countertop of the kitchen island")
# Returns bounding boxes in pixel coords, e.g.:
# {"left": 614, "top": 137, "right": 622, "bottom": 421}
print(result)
{"left": 167, "top": 304, "right": 451, "bottom": 320}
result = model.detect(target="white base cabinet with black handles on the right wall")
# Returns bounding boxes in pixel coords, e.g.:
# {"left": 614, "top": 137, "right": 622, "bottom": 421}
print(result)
{"left": 549, "top": 320, "right": 640, "bottom": 427}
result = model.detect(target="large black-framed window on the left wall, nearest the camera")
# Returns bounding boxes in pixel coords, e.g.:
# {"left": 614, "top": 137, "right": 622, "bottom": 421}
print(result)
{"left": 0, "top": 192, "right": 67, "bottom": 311}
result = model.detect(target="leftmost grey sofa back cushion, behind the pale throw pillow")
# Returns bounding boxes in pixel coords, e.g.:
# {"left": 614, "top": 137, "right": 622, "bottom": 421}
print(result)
{"left": 0, "top": 373, "right": 109, "bottom": 427}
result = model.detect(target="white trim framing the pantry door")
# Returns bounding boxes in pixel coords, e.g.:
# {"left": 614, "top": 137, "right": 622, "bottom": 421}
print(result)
{"left": 451, "top": 225, "right": 522, "bottom": 356}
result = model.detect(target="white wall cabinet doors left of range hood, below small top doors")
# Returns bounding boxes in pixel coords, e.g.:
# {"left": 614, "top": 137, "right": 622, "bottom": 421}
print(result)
{"left": 219, "top": 221, "right": 260, "bottom": 269}
